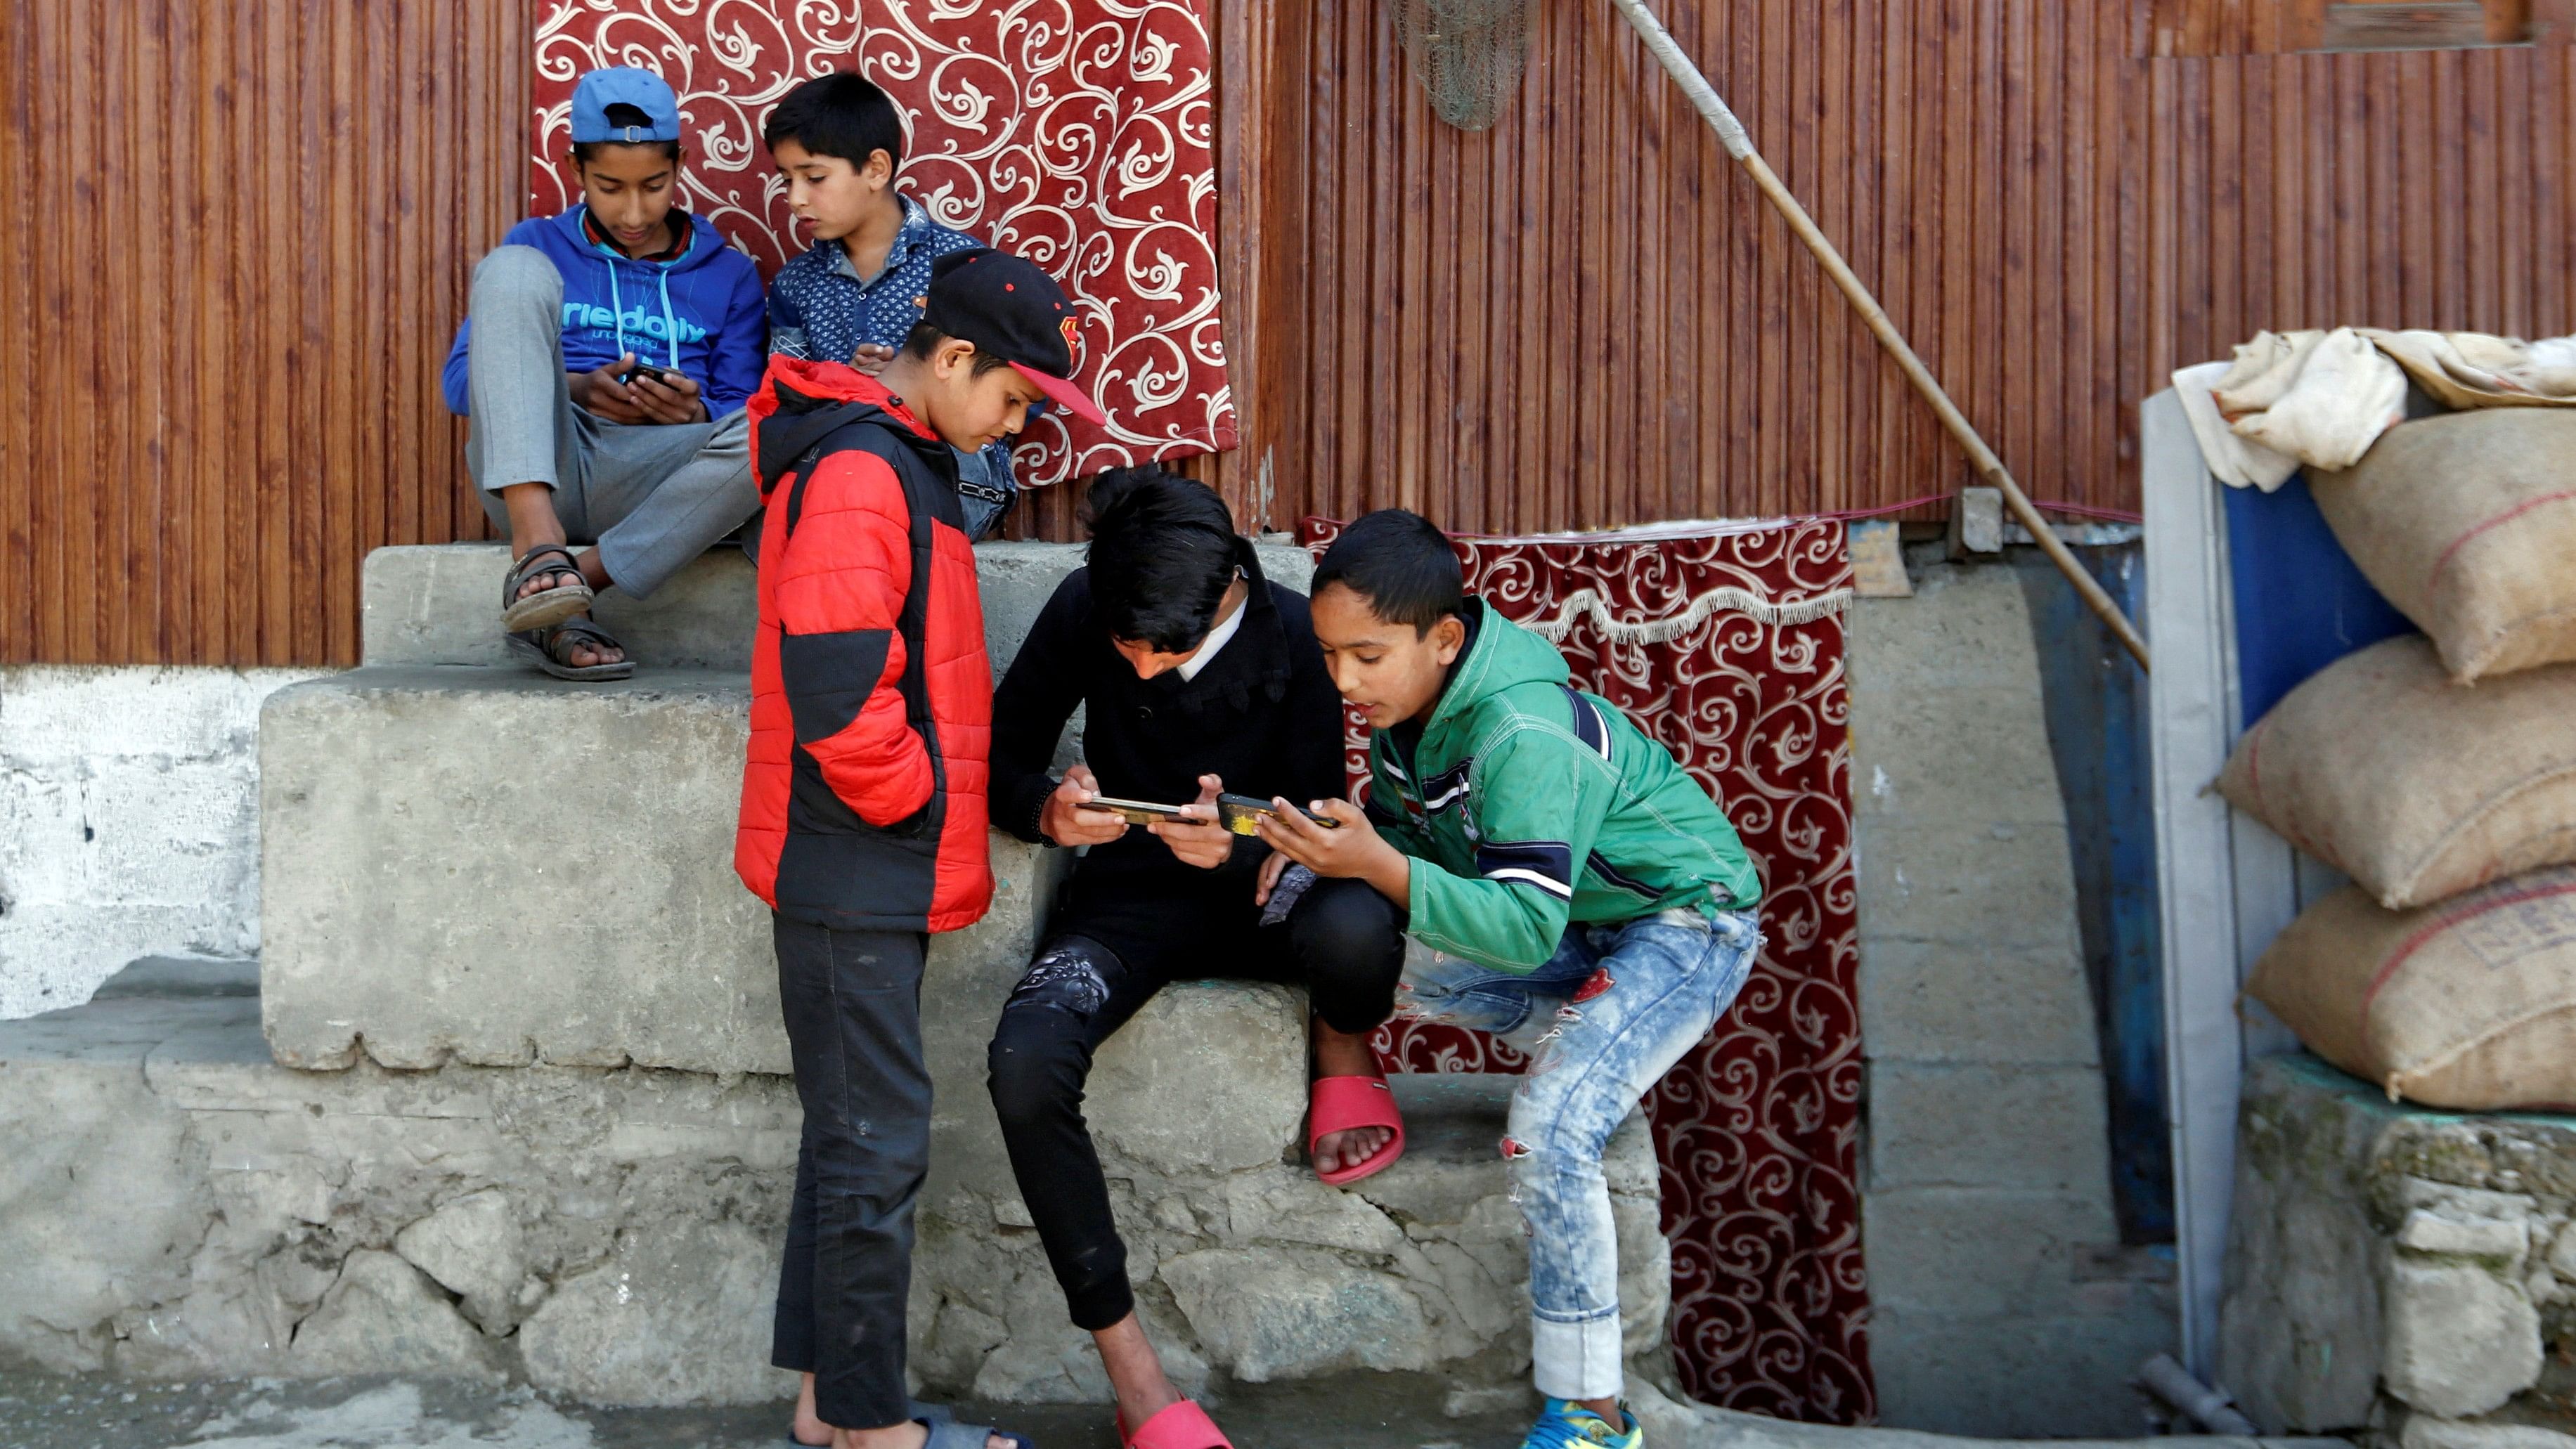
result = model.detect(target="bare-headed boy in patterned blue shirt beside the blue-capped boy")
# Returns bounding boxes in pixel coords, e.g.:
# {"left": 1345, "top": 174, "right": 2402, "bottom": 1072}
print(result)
{"left": 763, "top": 72, "right": 1038, "bottom": 538}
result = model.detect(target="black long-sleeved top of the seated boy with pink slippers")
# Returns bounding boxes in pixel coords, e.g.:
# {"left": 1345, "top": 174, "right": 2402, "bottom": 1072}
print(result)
{"left": 992, "top": 540, "right": 1347, "bottom": 890}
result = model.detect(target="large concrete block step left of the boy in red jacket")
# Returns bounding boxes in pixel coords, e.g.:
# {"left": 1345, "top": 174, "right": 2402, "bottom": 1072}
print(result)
{"left": 260, "top": 667, "right": 870, "bottom": 1071}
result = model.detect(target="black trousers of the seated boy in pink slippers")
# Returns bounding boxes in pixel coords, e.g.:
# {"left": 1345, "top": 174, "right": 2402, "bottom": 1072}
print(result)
{"left": 987, "top": 878, "right": 1404, "bottom": 1331}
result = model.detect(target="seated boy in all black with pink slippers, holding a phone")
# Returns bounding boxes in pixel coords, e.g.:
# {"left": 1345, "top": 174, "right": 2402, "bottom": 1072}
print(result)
{"left": 992, "top": 469, "right": 1404, "bottom": 1449}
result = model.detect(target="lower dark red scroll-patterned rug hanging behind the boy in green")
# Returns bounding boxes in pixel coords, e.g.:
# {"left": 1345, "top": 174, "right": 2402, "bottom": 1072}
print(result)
{"left": 1303, "top": 520, "right": 1875, "bottom": 1423}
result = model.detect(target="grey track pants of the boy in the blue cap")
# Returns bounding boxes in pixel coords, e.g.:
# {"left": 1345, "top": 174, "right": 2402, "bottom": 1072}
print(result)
{"left": 466, "top": 247, "right": 760, "bottom": 597}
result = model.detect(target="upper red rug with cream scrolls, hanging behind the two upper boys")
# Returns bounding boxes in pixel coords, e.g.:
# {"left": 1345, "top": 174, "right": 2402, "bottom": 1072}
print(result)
{"left": 531, "top": 0, "right": 1236, "bottom": 484}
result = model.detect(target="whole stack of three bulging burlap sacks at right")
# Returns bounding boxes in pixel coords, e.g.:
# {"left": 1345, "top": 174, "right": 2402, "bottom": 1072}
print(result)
{"left": 2218, "top": 409, "right": 2576, "bottom": 1110}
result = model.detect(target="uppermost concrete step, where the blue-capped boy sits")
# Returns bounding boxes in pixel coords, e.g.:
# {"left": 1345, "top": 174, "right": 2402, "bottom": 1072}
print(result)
{"left": 361, "top": 543, "right": 1314, "bottom": 675}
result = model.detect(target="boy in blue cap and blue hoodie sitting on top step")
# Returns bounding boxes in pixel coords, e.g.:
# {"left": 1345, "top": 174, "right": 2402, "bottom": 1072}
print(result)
{"left": 441, "top": 67, "right": 768, "bottom": 680}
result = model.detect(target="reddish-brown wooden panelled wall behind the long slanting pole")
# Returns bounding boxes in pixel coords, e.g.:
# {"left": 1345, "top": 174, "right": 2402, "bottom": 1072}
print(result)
{"left": 1174, "top": 0, "right": 2576, "bottom": 545}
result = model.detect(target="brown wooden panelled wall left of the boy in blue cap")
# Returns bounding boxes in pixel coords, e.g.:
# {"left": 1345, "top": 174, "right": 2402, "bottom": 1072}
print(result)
{"left": 0, "top": 0, "right": 531, "bottom": 664}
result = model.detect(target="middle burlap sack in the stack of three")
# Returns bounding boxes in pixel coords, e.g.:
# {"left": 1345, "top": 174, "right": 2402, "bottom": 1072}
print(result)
{"left": 2218, "top": 633, "right": 2576, "bottom": 911}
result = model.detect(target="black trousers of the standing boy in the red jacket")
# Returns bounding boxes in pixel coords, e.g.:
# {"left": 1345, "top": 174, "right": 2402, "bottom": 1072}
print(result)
{"left": 770, "top": 916, "right": 930, "bottom": 1429}
